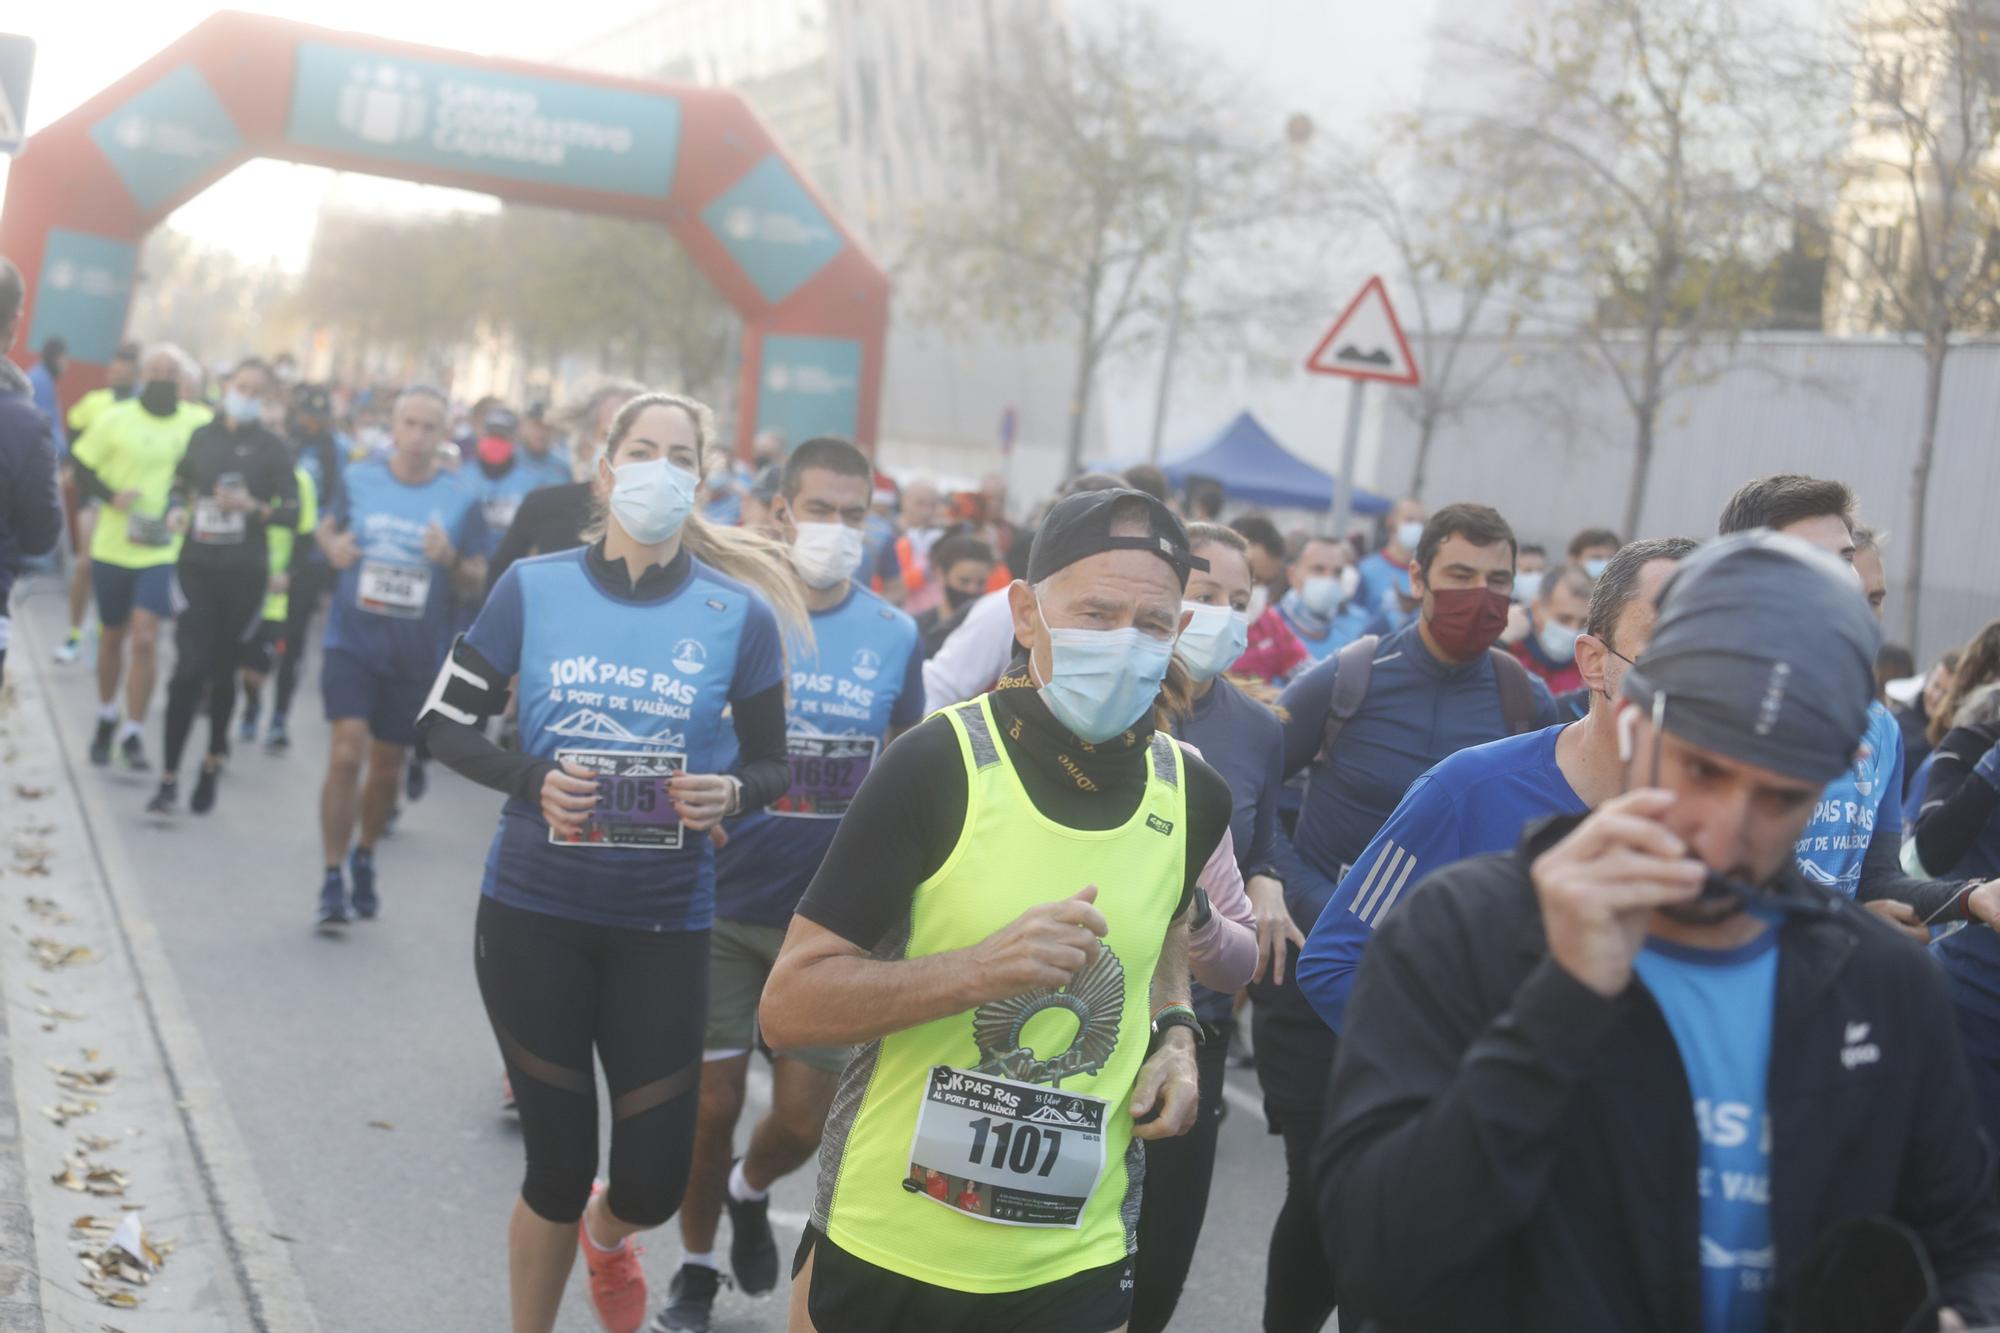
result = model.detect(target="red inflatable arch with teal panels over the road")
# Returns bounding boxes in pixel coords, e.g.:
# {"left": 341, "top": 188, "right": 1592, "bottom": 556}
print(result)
{"left": 0, "top": 12, "right": 888, "bottom": 450}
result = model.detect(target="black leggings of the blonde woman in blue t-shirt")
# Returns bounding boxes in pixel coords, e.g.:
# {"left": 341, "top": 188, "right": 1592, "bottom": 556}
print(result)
{"left": 474, "top": 897, "right": 708, "bottom": 1227}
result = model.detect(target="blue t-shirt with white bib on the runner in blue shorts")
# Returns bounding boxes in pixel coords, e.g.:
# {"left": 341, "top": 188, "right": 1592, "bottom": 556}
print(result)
{"left": 326, "top": 458, "right": 486, "bottom": 681}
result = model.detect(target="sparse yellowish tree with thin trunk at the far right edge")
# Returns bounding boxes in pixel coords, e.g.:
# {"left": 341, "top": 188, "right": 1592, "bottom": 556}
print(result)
{"left": 1828, "top": 0, "right": 2000, "bottom": 642}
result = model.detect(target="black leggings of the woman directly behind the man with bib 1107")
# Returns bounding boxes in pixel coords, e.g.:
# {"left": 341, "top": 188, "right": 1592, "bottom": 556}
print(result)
{"left": 1128, "top": 1023, "right": 1230, "bottom": 1333}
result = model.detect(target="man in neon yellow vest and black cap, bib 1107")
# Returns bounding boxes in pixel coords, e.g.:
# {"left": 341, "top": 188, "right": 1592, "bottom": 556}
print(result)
{"left": 760, "top": 490, "right": 1230, "bottom": 1333}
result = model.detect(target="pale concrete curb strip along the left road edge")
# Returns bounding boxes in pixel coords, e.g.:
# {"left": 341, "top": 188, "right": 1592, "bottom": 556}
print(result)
{"left": 14, "top": 616, "right": 320, "bottom": 1333}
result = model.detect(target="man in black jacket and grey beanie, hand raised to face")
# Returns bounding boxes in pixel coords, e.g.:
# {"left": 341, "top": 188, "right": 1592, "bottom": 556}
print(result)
{"left": 1320, "top": 534, "right": 2000, "bottom": 1333}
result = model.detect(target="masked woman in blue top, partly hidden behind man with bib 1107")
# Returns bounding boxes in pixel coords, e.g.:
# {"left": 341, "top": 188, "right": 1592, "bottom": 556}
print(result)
{"left": 1130, "top": 522, "right": 1304, "bottom": 1333}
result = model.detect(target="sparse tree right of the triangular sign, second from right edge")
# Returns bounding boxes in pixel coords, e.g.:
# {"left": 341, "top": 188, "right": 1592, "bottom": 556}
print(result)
{"left": 1460, "top": 0, "right": 1794, "bottom": 532}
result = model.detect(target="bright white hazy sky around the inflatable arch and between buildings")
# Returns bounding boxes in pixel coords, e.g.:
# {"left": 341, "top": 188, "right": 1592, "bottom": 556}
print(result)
{"left": 0, "top": 0, "right": 1436, "bottom": 266}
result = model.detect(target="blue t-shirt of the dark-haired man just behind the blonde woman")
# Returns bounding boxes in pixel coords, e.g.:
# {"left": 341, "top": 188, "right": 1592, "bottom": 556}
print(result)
{"left": 716, "top": 582, "right": 924, "bottom": 927}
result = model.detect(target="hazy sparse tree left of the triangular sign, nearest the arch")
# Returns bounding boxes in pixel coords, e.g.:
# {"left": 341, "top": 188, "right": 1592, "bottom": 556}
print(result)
{"left": 910, "top": 8, "right": 1282, "bottom": 476}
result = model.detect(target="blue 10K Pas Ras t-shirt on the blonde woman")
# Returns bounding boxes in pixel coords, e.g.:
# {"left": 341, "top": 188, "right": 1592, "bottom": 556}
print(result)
{"left": 466, "top": 548, "right": 784, "bottom": 931}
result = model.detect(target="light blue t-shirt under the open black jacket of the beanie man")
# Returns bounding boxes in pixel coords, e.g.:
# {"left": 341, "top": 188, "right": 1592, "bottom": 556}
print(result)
{"left": 1636, "top": 927, "right": 1778, "bottom": 1333}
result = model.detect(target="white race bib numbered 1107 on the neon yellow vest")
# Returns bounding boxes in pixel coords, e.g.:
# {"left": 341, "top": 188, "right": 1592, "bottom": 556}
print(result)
{"left": 902, "top": 1065, "right": 1110, "bottom": 1227}
